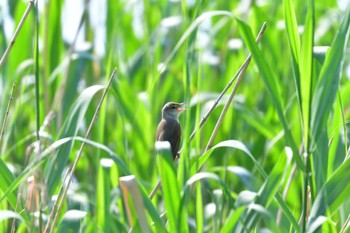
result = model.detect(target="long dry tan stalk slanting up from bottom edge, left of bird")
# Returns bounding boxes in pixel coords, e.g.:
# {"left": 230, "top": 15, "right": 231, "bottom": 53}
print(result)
{"left": 44, "top": 68, "right": 117, "bottom": 232}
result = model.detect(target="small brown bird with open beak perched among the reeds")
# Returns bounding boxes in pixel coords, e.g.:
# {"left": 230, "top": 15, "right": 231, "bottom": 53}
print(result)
{"left": 156, "top": 102, "right": 186, "bottom": 159}
